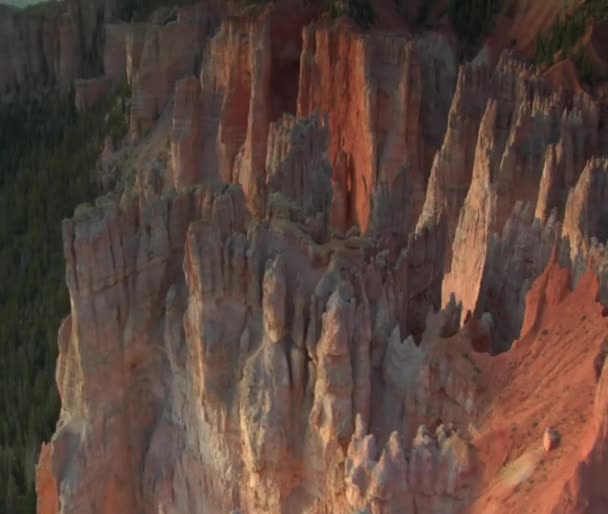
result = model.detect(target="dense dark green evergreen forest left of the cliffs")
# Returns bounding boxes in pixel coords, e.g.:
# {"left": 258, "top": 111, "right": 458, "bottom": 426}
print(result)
{"left": 0, "top": 88, "right": 127, "bottom": 514}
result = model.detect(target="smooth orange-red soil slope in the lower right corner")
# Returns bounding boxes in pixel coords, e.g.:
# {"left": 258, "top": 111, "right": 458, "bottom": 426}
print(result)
{"left": 458, "top": 249, "right": 608, "bottom": 514}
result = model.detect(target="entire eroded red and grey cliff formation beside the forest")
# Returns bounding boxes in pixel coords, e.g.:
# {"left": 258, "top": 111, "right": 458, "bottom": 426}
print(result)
{"left": 32, "top": 1, "right": 608, "bottom": 514}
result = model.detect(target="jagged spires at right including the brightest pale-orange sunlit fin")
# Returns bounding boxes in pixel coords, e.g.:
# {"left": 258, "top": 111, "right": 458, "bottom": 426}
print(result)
{"left": 436, "top": 54, "right": 600, "bottom": 341}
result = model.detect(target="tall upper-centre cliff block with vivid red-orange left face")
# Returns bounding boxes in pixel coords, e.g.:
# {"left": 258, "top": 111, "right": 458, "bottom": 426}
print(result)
{"left": 298, "top": 24, "right": 457, "bottom": 234}
